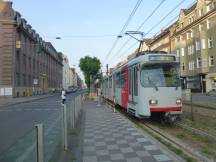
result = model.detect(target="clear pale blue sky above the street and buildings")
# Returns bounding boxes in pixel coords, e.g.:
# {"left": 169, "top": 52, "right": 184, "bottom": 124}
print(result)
{"left": 13, "top": 0, "right": 195, "bottom": 77}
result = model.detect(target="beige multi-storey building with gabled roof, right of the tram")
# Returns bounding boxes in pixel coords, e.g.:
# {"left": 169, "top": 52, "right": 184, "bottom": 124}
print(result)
{"left": 171, "top": 0, "right": 216, "bottom": 92}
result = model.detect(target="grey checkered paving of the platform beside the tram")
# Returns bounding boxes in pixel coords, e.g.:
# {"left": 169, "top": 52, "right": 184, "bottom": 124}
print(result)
{"left": 83, "top": 103, "right": 183, "bottom": 162}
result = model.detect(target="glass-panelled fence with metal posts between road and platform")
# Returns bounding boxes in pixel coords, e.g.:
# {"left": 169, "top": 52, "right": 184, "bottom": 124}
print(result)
{"left": 0, "top": 92, "right": 85, "bottom": 162}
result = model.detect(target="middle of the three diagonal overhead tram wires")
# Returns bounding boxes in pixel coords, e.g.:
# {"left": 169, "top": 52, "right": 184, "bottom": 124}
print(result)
{"left": 107, "top": 0, "right": 166, "bottom": 64}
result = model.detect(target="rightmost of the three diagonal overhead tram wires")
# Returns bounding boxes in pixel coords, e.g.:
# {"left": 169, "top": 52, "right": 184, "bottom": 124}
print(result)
{"left": 111, "top": 0, "right": 186, "bottom": 64}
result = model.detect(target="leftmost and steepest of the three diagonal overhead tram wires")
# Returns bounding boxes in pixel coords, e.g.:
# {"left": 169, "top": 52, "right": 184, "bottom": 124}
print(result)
{"left": 103, "top": 0, "right": 143, "bottom": 63}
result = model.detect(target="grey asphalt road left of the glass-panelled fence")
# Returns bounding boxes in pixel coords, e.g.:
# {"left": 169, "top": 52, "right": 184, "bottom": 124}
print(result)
{"left": 0, "top": 92, "right": 83, "bottom": 155}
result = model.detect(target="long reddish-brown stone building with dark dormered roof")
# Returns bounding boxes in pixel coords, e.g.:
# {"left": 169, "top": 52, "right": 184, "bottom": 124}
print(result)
{"left": 0, "top": 0, "right": 62, "bottom": 97}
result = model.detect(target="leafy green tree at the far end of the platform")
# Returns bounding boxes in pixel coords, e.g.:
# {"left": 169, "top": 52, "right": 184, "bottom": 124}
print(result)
{"left": 79, "top": 56, "right": 101, "bottom": 88}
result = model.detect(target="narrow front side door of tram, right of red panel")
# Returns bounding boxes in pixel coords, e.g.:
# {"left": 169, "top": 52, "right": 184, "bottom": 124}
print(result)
{"left": 129, "top": 65, "right": 138, "bottom": 108}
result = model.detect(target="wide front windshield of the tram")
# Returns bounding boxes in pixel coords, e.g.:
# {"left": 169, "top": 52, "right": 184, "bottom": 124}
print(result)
{"left": 140, "top": 64, "right": 180, "bottom": 87}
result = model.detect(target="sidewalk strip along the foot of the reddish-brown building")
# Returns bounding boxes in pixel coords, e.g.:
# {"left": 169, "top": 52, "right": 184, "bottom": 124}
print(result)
{"left": 0, "top": 93, "right": 58, "bottom": 108}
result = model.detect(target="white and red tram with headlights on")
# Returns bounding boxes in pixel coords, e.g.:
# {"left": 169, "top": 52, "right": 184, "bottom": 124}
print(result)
{"left": 102, "top": 52, "right": 182, "bottom": 122}
